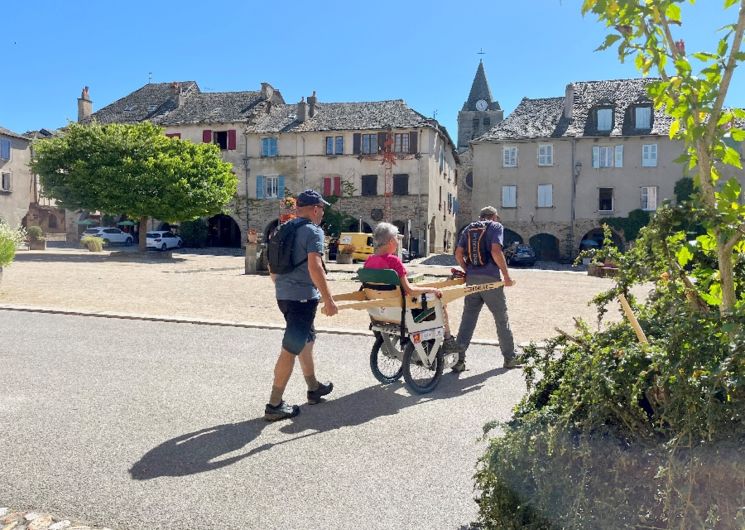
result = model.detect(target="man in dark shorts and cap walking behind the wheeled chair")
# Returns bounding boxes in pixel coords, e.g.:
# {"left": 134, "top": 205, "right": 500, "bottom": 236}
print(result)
{"left": 264, "top": 190, "right": 338, "bottom": 421}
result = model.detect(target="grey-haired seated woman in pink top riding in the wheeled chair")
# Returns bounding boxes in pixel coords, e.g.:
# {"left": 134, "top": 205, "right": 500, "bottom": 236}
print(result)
{"left": 365, "top": 223, "right": 460, "bottom": 353}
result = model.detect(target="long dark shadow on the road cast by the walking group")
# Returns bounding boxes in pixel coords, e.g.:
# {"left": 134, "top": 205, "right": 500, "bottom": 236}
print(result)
{"left": 129, "top": 368, "right": 505, "bottom": 480}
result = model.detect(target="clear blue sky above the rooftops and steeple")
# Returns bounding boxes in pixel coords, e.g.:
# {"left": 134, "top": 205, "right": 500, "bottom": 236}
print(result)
{"left": 0, "top": 0, "right": 745, "bottom": 138}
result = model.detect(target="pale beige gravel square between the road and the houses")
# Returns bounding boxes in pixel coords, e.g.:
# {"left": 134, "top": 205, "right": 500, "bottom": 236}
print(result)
{"left": 0, "top": 248, "right": 644, "bottom": 343}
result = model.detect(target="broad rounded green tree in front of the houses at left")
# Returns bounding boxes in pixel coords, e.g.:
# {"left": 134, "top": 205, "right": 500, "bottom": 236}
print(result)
{"left": 31, "top": 122, "right": 237, "bottom": 250}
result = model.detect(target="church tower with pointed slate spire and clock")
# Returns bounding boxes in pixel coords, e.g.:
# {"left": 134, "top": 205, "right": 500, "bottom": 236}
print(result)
{"left": 456, "top": 61, "right": 504, "bottom": 232}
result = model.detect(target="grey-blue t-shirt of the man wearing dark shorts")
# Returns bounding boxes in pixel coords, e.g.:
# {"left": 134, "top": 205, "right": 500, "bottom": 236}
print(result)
{"left": 274, "top": 219, "right": 323, "bottom": 300}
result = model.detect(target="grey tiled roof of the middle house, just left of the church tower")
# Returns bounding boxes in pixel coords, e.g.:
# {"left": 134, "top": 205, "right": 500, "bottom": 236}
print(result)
{"left": 254, "top": 99, "right": 436, "bottom": 133}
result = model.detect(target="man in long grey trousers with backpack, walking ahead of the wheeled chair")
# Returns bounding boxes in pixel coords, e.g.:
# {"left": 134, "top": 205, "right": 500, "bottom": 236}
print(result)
{"left": 452, "top": 206, "right": 520, "bottom": 372}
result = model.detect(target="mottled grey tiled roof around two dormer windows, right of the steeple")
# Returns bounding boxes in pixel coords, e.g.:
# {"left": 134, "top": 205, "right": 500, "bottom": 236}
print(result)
{"left": 476, "top": 78, "right": 672, "bottom": 141}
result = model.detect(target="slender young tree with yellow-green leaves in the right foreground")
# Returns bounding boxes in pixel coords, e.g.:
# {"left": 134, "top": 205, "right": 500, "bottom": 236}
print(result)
{"left": 582, "top": 0, "right": 745, "bottom": 313}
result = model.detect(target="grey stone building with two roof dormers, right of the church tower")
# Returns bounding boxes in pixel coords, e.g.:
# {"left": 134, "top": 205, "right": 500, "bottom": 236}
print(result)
{"left": 472, "top": 79, "right": 684, "bottom": 259}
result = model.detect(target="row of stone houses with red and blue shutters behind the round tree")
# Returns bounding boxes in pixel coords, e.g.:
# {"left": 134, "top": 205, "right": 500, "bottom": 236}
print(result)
{"left": 78, "top": 81, "right": 457, "bottom": 252}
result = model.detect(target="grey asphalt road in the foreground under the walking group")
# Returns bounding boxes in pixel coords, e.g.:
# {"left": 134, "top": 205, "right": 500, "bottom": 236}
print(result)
{"left": 0, "top": 311, "right": 524, "bottom": 530}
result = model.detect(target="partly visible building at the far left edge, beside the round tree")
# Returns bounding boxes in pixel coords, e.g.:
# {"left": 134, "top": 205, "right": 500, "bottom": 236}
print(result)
{"left": 0, "top": 127, "right": 33, "bottom": 228}
